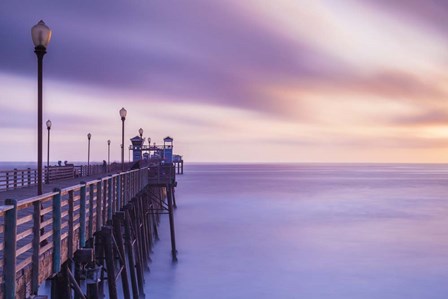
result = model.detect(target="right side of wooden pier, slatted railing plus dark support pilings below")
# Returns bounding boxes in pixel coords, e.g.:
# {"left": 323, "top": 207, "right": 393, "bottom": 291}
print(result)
{"left": 0, "top": 161, "right": 179, "bottom": 299}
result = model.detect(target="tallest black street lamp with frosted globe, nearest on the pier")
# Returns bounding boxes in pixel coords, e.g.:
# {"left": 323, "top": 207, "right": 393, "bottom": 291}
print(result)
{"left": 31, "top": 20, "right": 51, "bottom": 195}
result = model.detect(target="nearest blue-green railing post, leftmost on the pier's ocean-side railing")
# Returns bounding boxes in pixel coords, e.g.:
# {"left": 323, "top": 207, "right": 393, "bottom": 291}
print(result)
{"left": 3, "top": 199, "right": 17, "bottom": 299}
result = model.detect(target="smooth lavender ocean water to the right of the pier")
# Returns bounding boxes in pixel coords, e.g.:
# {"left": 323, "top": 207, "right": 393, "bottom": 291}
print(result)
{"left": 145, "top": 164, "right": 448, "bottom": 299}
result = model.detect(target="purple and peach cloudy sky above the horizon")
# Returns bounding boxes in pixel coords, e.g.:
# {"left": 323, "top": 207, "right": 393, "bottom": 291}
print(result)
{"left": 0, "top": 0, "right": 448, "bottom": 163}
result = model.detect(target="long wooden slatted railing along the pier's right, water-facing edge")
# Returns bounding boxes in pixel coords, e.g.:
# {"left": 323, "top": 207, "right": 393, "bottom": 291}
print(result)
{"left": 0, "top": 168, "right": 149, "bottom": 298}
